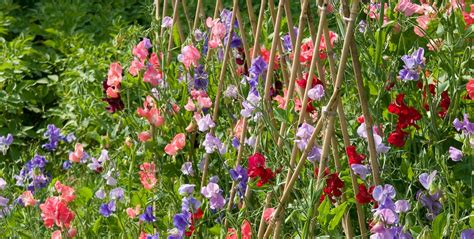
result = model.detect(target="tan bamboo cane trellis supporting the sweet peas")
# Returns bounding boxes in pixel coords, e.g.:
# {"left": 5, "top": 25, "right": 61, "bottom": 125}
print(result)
{"left": 155, "top": 0, "right": 381, "bottom": 238}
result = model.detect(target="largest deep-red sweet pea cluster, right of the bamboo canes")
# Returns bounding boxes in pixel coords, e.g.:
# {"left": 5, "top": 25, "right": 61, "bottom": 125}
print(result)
{"left": 388, "top": 94, "right": 421, "bottom": 147}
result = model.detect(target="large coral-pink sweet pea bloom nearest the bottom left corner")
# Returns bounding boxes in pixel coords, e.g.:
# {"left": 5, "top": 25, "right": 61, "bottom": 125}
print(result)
{"left": 39, "top": 197, "right": 75, "bottom": 228}
